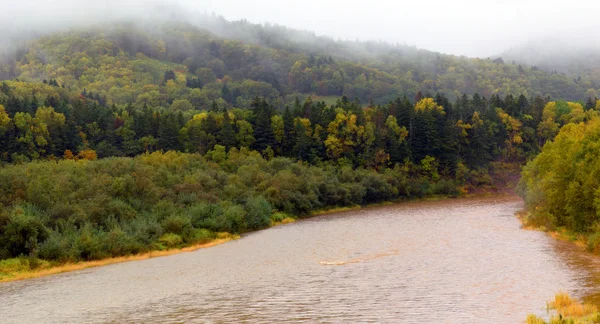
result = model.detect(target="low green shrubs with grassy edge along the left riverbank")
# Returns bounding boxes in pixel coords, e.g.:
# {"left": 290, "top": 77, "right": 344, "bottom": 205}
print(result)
{"left": 0, "top": 146, "right": 474, "bottom": 275}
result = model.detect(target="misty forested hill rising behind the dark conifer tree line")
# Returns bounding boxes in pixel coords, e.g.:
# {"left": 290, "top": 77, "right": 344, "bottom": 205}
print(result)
{"left": 0, "top": 16, "right": 596, "bottom": 109}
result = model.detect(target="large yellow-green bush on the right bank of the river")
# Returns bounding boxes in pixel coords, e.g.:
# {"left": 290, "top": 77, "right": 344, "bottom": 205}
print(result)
{"left": 518, "top": 118, "right": 600, "bottom": 232}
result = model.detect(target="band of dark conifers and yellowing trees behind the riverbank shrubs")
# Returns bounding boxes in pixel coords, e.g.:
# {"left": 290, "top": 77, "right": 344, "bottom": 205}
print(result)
{"left": 5, "top": 82, "right": 597, "bottom": 170}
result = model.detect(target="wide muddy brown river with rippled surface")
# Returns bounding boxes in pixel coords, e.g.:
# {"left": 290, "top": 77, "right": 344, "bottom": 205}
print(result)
{"left": 0, "top": 196, "right": 600, "bottom": 323}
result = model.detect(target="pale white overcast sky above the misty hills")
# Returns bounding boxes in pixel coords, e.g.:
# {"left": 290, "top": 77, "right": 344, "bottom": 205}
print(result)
{"left": 0, "top": 0, "right": 600, "bottom": 57}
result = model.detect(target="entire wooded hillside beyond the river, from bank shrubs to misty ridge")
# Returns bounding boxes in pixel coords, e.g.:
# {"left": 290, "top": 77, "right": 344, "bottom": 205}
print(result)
{"left": 0, "top": 17, "right": 600, "bottom": 264}
